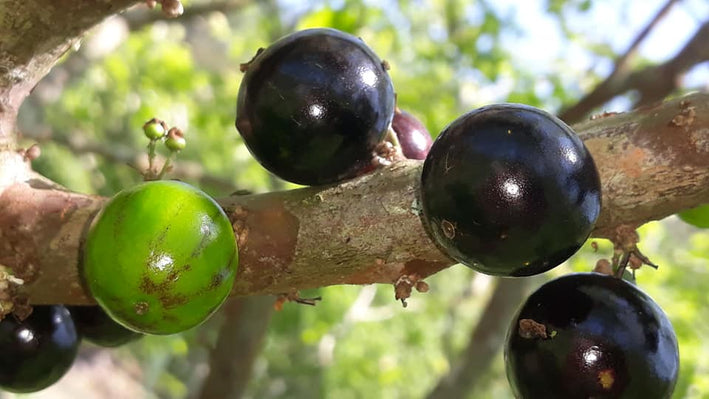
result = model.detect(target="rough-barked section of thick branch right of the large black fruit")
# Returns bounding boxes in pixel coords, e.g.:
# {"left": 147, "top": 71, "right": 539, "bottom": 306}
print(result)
{"left": 574, "top": 94, "right": 709, "bottom": 237}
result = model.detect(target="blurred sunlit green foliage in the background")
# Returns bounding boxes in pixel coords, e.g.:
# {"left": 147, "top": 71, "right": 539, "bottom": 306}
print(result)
{"left": 13, "top": 0, "right": 709, "bottom": 398}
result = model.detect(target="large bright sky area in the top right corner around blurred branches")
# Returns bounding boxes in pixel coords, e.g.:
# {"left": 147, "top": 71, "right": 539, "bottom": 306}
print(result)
{"left": 491, "top": 0, "right": 709, "bottom": 86}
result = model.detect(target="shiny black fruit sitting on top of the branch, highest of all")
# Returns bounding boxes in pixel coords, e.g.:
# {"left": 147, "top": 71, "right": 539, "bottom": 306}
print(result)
{"left": 236, "top": 28, "right": 394, "bottom": 185}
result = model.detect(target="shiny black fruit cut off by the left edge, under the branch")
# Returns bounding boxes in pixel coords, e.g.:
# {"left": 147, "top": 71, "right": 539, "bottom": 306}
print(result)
{"left": 0, "top": 305, "right": 81, "bottom": 393}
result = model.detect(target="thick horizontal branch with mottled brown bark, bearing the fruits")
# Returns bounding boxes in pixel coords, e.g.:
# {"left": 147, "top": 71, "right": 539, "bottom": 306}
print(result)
{"left": 0, "top": 94, "right": 709, "bottom": 303}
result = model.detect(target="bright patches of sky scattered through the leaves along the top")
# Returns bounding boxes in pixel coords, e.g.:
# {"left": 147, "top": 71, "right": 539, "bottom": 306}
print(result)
{"left": 280, "top": 0, "right": 709, "bottom": 111}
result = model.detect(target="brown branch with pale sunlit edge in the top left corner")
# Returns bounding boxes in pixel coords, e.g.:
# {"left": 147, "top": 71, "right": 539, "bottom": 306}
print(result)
{"left": 0, "top": 0, "right": 138, "bottom": 150}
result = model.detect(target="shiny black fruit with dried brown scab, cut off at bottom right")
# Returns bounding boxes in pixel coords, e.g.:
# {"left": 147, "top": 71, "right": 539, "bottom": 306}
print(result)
{"left": 505, "top": 273, "right": 679, "bottom": 399}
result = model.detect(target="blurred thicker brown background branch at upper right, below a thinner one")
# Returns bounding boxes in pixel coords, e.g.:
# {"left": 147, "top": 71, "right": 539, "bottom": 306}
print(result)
{"left": 559, "top": 18, "right": 709, "bottom": 123}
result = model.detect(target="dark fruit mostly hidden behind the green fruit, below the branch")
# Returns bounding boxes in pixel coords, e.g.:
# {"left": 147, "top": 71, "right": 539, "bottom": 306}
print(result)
{"left": 69, "top": 306, "right": 143, "bottom": 348}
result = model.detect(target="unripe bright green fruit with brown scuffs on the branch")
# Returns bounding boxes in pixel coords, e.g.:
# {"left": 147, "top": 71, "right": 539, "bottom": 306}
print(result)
{"left": 83, "top": 181, "right": 239, "bottom": 335}
